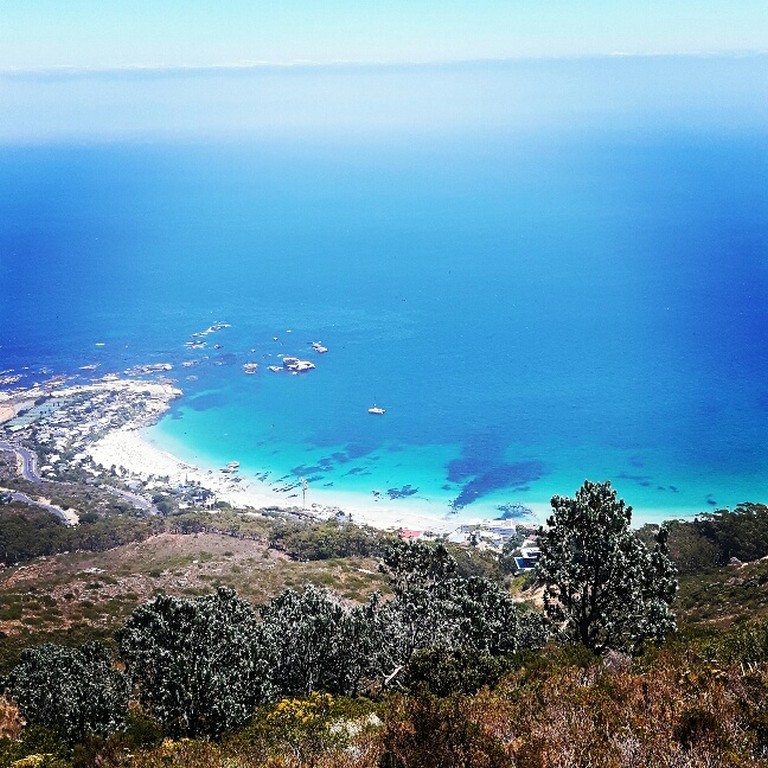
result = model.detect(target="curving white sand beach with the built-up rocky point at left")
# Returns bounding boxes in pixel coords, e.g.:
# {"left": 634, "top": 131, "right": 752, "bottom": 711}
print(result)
{"left": 0, "top": 368, "right": 728, "bottom": 535}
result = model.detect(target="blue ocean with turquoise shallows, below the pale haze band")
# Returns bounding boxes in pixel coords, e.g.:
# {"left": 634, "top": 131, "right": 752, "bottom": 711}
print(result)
{"left": 0, "top": 58, "right": 768, "bottom": 519}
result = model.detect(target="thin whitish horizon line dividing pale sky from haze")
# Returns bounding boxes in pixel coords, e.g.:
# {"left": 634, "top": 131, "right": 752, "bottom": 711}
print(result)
{"left": 0, "top": 49, "right": 768, "bottom": 76}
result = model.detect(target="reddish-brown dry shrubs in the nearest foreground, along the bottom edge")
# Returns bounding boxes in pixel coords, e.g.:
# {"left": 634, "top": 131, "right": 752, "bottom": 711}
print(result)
{"left": 16, "top": 649, "right": 768, "bottom": 768}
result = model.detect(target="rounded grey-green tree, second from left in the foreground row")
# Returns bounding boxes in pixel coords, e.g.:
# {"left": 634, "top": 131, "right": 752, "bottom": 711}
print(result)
{"left": 118, "top": 587, "right": 269, "bottom": 737}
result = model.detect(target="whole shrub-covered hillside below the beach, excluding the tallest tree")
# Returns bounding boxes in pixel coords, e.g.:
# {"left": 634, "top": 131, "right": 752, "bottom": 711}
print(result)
{"left": 0, "top": 476, "right": 768, "bottom": 768}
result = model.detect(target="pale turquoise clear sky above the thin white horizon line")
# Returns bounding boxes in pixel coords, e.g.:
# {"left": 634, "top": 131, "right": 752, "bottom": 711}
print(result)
{"left": 0, "top": 0, "right": 768, "bottom": 69}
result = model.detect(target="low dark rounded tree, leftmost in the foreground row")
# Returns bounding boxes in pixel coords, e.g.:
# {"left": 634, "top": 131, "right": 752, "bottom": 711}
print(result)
{"left": 6, "top": 642, "right": 129, "bottom": 744}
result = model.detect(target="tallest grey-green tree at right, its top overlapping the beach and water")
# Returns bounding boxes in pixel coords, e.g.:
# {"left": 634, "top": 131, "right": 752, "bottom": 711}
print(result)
{"left": 537, "top": 480, "right": 677, "bottom": 653}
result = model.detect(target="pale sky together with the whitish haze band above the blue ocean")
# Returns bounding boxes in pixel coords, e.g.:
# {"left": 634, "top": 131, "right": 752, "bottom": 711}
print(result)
{"left": 0, "top": 0, "right": 768, "bottom": 144}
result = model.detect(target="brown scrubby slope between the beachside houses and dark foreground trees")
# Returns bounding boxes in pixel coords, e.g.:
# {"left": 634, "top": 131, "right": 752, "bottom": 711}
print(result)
{"left": 0, "top": 533, "right": 384, "bottom": 656}
